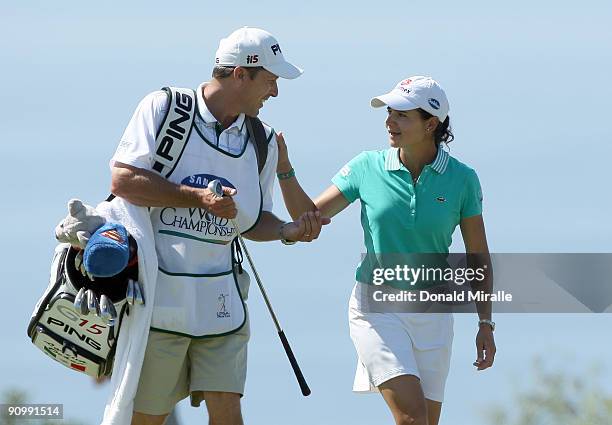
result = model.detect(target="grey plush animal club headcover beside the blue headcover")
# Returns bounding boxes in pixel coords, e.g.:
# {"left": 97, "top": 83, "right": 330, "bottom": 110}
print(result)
{"left": 55, "top": 199, "right": 106, "bottom": 249}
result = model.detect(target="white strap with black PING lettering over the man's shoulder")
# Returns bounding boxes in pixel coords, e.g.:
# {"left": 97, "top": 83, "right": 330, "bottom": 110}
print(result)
{"left": 153, "top": 87, "right": 196, "bottom": 178}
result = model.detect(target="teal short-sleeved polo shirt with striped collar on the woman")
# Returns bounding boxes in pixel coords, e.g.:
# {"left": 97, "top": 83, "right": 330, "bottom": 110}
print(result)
{"left": 332, "top": 148, "right": 482, "bottom": 289}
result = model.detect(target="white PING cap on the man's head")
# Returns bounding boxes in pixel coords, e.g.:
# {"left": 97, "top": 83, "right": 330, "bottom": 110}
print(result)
{"left": 215, "top": 27, "right": 304, "bottom": 80}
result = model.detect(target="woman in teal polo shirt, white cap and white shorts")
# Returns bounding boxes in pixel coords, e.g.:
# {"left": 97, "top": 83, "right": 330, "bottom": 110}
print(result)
{"left": 277, "top": 76, "right": 495, "bottom": 425}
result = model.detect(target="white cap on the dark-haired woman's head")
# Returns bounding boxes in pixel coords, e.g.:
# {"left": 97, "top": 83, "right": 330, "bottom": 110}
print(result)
{"left": 370, "top": 75, "right": 449, "bottom": 122}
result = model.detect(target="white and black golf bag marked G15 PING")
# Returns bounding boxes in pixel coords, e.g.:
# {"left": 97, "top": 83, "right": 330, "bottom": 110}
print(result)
{"left": 28, "top": 244, "right": 126, "bottom": 377}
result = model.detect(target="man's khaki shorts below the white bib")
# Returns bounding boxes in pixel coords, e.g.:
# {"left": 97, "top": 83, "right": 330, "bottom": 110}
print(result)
{"left": 134, "top": 305, "right": 250, "bottom": 415}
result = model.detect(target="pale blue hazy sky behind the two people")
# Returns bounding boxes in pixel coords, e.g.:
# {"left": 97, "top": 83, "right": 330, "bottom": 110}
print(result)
{"left": 0, "top": 0, "right": 612, "bottom": 425}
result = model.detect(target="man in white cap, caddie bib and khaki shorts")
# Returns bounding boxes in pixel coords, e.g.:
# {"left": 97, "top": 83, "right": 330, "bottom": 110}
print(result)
{"left": 111, "top": 27, "right": 324, "bottom": 425}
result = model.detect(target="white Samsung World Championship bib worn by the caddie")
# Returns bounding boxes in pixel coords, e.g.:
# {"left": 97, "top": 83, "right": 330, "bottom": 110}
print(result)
{"left": 150, "top": 116, "right": 262, "bottom": 337}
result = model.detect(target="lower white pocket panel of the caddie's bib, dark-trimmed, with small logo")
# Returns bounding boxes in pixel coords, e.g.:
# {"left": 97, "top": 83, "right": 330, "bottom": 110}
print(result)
{"left": 151, "top": 269, "right": 248, "bottom": 338}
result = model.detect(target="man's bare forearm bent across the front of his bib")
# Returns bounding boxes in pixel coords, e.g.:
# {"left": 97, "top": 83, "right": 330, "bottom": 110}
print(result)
{"left": 111, "top": 166, "right": 203, "bottom": 208}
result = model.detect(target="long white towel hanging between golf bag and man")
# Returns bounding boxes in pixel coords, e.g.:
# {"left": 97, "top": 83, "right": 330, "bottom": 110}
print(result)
{"left": 96, "top": 198, "right": 157, "bottom": 425}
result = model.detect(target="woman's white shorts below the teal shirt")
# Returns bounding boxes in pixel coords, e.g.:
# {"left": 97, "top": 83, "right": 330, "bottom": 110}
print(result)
{"left": 349, "top": 282, "right": 454, "bottom": 402}
